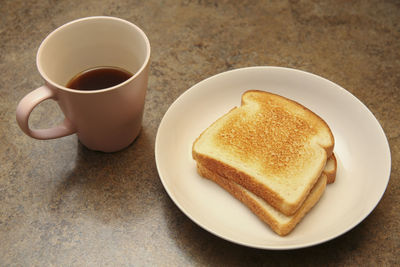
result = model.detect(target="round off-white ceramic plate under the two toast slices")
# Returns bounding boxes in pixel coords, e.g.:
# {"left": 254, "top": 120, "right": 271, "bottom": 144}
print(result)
{"left": 155, "top": 67, "right": 391, "bottom": 249}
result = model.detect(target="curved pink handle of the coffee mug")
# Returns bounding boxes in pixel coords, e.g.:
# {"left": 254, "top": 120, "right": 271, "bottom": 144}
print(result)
{"left": 17, "top": 85, "right": 76, "bottom": 140}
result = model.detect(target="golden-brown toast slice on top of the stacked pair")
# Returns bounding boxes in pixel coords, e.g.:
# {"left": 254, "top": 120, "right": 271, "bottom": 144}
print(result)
{"left": 192, "top": 90, "right": 334, "bottom": 215}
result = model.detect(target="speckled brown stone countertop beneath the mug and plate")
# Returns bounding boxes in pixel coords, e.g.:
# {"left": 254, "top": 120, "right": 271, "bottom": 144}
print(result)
{"left": 0, "top": 0, "right": 400, "bottom": 266}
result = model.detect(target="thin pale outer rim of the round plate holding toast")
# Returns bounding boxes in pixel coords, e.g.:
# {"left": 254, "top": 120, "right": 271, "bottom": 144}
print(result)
{"left": 155, "top": 66, "right": 392, "bottom": 250}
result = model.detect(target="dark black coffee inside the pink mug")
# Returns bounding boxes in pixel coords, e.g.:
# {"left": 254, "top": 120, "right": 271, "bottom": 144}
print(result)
{"left": 66, "top": 67, "right": 132, "bottom": 91}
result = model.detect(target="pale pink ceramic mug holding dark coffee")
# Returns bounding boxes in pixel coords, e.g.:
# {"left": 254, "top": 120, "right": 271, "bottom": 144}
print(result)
{"left": 17, "top": 16, "right": 150, "bottom": 152}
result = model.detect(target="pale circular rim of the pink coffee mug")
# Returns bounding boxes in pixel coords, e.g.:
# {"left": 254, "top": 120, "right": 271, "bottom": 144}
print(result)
{"left": 36, "top": 16, "right": 151, "bottom": 94}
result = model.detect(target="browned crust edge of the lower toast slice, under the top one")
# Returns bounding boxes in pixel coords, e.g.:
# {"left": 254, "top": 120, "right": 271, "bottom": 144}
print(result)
{"left": 197, "top": 164, "right": 327, "bottom": 236}
